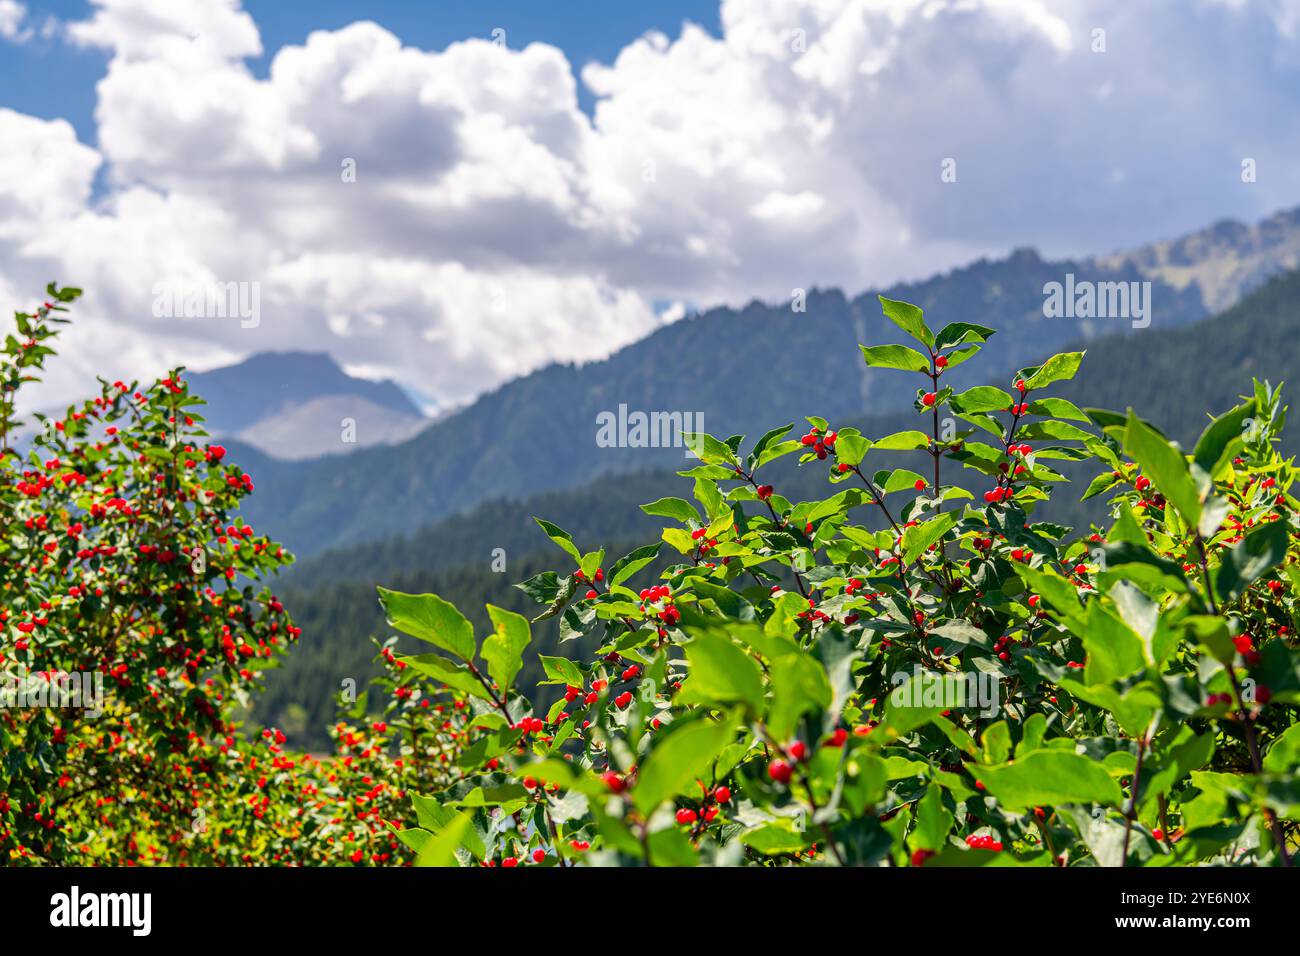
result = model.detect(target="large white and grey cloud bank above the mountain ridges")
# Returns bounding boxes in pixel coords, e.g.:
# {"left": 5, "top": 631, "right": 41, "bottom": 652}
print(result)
{"left": 0, "top": 0, "right": 1300, "bottom": 403}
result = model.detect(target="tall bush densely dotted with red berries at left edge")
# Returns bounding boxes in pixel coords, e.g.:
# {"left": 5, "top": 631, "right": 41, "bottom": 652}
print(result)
{"left": 0, "top": 285, "right": 323, "bottom": 865}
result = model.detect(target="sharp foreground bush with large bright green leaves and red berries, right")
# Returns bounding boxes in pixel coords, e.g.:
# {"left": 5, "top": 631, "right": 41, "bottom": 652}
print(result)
{"left": 380, "top": 298, "right": 1300, "bottom": 866}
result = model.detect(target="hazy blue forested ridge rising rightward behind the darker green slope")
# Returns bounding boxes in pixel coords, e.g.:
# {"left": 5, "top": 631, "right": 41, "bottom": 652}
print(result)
{"left": 233, "top": 209, "right": 1300, "bottom": 555}
